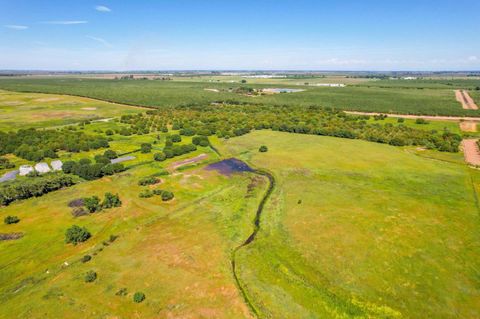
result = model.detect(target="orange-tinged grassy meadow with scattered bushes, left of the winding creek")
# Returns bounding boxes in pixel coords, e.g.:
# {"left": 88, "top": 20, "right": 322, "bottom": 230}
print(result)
{"left": 0, "top": 141, "right": 265, "bottom": 318}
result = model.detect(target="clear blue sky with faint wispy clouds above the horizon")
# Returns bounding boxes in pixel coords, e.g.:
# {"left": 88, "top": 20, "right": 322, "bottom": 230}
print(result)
{"left": 0, "top": 0, "right": 480, "bottom": 70}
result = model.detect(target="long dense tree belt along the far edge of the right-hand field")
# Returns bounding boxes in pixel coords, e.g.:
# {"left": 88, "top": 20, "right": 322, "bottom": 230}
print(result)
{"left": 123, "top": 103, "right": 461, "bottom": 152}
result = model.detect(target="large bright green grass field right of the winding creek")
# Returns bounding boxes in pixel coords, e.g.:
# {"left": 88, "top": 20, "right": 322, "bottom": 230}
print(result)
{"left": 220, "top": 131, "right": 480, "bottom": 318}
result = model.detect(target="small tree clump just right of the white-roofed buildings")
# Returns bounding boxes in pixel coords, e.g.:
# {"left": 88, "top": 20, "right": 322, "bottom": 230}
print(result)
{"left": 62, "top": 150, "right": 125, "bottom": 180}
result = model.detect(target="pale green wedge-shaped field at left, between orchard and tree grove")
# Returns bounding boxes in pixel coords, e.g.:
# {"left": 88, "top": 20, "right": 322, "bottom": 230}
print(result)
{"left": 0, "top": 91, "right": 145, "bottom": 131}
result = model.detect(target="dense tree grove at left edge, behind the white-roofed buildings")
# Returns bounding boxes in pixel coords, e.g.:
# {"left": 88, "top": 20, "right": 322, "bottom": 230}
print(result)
{"left": 0, "top": 128, "right": 109, "bottom": 162}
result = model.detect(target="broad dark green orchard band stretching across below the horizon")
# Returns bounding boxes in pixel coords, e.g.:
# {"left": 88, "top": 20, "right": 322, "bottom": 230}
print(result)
{"left": 0, "top": 77, "right": 480, "bottom": 116}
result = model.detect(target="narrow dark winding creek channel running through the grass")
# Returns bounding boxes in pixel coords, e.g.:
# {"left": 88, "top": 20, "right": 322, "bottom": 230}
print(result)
{"left": 231, "top": 169, "right": 275, "bottom": 317}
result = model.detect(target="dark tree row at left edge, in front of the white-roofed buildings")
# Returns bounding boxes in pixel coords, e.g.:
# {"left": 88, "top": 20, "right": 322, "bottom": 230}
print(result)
{"left": 0, "top": 173, "right": 75, "bottom": 205}
